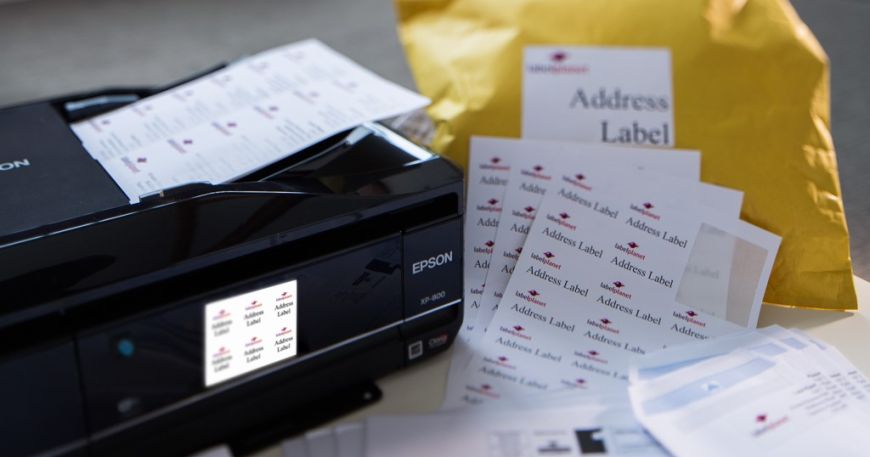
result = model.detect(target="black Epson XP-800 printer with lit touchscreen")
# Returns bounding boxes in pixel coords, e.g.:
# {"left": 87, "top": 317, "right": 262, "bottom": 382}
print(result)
{"left": 0, "top": 85, "right": 463, "bottom": 457}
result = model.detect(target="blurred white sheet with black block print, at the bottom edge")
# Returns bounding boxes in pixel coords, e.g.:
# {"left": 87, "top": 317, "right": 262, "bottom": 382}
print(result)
{"left": 366, "top": 400, "right": 667, "bottom": 457}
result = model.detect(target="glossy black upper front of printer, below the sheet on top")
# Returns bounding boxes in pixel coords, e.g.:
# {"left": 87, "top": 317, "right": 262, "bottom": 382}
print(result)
{"left": 0, "top": 119, "right": 462, "bottom": 326}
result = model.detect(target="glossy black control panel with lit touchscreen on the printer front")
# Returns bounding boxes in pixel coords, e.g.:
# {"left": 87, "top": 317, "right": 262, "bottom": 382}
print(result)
{"left": 78, "top": 234, "right": 403, "bottom": 433}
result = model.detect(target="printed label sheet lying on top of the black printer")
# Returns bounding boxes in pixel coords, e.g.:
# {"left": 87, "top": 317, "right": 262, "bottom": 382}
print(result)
{"left": 71, "top": 40, "right": 429, "bottom": 203}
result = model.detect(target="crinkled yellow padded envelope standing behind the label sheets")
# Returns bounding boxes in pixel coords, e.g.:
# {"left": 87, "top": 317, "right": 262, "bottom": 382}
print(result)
{"left": 396, "top": 0, "right": 857, "bottom": 310}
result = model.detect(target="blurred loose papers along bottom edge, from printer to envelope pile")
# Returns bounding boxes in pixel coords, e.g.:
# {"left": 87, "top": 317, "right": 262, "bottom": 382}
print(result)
{"left": 281, "top": 392, "right": 667, "bottom": 457}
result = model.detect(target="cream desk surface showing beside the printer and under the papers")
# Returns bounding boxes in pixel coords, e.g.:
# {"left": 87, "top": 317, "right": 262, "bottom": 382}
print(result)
{"left": 256, "top": 277, "right": 870, "bottom": 457}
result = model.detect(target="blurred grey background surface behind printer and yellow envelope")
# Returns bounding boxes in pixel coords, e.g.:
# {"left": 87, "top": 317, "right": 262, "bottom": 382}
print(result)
{"left": 0, "top": 0, "right": 870, "bottom": 278}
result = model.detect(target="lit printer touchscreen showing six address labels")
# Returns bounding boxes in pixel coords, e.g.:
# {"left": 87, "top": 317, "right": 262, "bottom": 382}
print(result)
{"left": 203, "top": 279, "right": 298, "bottom": 387}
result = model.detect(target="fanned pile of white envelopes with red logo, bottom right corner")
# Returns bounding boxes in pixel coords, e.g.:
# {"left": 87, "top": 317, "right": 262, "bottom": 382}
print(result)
{"left": 629, "top": 327, "right": 870, "bottom": 457}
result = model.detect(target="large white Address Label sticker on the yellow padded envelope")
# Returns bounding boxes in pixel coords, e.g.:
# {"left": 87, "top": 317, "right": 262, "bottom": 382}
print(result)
{"left": 522, "top": 46, "right": 676, "bottom": 146}
